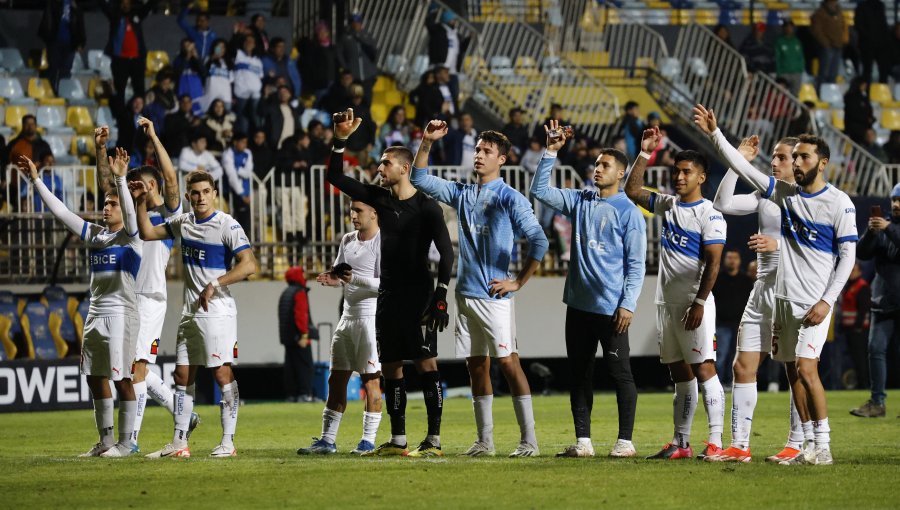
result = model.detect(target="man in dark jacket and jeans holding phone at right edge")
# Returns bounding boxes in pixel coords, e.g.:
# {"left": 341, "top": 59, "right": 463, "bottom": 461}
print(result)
{"left": 850, "top": 185, "right": 900, "bottom": 418}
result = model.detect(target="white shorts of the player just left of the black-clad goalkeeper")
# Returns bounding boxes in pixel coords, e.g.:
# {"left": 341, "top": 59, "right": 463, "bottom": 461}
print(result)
{"left": 331, "top": 315, "right": 381, "bottom": 375}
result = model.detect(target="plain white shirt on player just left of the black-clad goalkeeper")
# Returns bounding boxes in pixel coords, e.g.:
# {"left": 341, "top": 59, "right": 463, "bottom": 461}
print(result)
{"left": 334, "top": 230, "right": 381, "bottom": 319}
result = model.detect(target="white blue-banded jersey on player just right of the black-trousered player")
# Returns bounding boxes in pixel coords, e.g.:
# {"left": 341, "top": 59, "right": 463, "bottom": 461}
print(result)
{"left": 649, "top": 193, "right": 727, "bottom": 305}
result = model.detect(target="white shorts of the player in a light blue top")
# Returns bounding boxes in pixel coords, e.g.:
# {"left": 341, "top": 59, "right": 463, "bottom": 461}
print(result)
{"left": 456, "top": 294, "right": 519, "bottom": 358}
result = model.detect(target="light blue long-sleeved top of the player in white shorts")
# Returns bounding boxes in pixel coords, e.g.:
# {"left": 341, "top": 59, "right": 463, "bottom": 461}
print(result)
{"left": 410, "top": 168, "right": 549, "bottom": 299}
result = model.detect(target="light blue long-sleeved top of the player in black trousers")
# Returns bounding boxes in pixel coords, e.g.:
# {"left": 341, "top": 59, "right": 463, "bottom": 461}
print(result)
{"left": 531, "top": 154, "right": 647, "bottom": 315}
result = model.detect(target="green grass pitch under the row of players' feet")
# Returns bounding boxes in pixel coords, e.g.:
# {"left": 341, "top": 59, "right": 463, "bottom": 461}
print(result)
{"left": 0, "top": 392, "right": 900, "bottom": 509}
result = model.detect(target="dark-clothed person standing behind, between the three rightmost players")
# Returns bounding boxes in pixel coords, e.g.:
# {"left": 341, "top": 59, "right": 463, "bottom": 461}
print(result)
{"left": 713, "top": 250, "right": 753, "bottom": 386}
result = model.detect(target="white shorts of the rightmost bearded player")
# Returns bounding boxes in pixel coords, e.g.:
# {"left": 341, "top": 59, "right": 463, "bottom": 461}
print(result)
{"left": 772, "top": 298, "right": 831, "bottom": 362}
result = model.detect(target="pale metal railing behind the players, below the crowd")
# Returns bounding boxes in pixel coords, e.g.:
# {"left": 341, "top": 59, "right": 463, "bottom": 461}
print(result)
{"left": 0, "top": 165, "right": 644, "bottom": 283}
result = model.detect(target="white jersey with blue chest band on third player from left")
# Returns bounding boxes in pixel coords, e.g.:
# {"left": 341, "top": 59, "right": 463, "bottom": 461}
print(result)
{"left": 165, "top": 211, "right": 250, "bottom": 317}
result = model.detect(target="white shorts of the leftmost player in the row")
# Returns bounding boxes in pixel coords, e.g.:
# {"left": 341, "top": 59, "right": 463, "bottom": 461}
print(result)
{"left": 81, "top": 314, "right": 141, "bottom": 381}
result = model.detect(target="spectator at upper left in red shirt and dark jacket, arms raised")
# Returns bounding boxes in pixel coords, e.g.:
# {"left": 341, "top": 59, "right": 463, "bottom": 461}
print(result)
{"left": 100, "top": 0, "right": 157, "bottom": 109}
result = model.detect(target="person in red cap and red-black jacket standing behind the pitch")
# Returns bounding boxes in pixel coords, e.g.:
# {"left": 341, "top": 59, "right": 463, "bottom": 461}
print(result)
{"left": 278, "top": 267, "right": 318, "bottom": 402}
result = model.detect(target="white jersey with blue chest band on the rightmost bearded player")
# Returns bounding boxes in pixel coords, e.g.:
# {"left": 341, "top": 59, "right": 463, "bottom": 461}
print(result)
{"left": 763, "top": 177, "right": 859, "bottom": 306}
